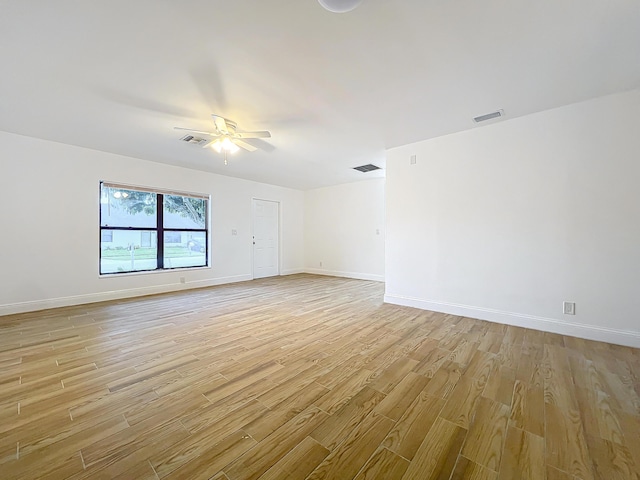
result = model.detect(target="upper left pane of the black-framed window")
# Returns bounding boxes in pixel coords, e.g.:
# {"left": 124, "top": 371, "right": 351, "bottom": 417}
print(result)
{"left": 100, "top": 185, "right": 157, "bottom": 228}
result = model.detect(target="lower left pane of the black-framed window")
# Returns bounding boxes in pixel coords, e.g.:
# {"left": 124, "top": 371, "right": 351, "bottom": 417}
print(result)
{"left": 100, "top": 230, "right": 158, "bottom": 274}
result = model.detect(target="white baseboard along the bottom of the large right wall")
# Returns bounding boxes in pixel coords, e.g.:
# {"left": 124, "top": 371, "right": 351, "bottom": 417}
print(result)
{"left": 384, "top": 294, "right": 640, "bottom": 348}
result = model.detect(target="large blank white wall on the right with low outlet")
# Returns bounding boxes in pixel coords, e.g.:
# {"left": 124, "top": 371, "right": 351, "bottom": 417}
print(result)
{"left": 385, "top": 90, "right": 640, "bottom": 346}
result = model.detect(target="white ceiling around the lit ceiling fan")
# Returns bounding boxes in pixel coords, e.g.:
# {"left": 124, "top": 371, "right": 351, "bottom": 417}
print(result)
{"left": 0, "top": 0, "right": 640, "bottom": 189}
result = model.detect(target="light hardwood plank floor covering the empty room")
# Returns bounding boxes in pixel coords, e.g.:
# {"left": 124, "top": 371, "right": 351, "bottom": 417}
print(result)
{"left": 0, "top": 275, "right": 640, "bottom": 480}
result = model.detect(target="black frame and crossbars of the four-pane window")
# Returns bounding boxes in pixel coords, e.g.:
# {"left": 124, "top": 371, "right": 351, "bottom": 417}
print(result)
{"left": 98, "top": 181, "right": 211, "bottom": 276}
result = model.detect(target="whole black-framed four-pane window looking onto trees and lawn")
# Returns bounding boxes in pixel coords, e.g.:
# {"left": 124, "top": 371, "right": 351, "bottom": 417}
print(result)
{"left": 100, "top": 182, "right": 209, "bottom": 275}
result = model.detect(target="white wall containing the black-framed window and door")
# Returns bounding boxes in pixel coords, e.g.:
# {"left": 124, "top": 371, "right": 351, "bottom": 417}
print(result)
{"left": 0, "top": 132, "right": 304, "bottom": 314}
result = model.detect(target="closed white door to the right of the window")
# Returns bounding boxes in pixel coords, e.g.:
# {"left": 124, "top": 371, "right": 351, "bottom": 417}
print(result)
{"left": 253, "top": 198, "right": 280, "bottom": 278}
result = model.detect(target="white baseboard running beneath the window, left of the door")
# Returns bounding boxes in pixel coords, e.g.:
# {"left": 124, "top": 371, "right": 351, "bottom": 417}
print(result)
{"left": 0, "top": 275, "right": 252, "bottom": 316}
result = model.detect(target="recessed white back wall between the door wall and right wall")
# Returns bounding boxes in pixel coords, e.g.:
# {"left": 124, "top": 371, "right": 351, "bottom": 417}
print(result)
{"left": 304, "top": 178, "right": 384, "bottom": 281}
